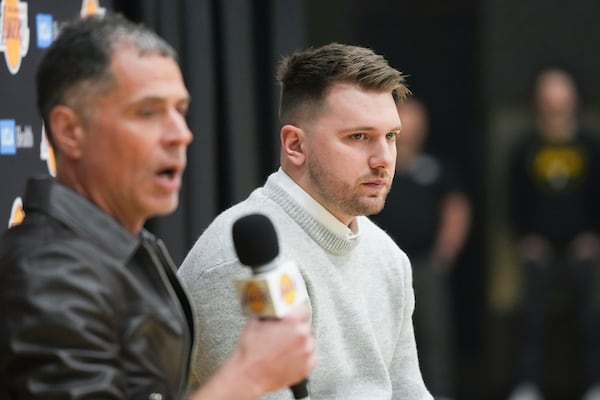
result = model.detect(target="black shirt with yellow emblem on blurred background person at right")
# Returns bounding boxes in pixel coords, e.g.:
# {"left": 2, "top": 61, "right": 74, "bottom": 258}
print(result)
{"left": 509, "top": 132, "right": 600, "bottom": 245}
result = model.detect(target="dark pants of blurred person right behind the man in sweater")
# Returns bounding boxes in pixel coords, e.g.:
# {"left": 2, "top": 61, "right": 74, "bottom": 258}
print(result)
{"left": 412, "top": 258, "right": 455, "bottom": 397}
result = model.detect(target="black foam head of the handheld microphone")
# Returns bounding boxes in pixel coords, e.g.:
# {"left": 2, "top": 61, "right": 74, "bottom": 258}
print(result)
{"left": 232, "top": 214, "right": 279, "bottom": 268}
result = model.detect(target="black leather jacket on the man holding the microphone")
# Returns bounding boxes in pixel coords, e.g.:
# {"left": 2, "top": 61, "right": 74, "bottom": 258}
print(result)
{"left": 0, "top": 178, "right": 193, "bottom": 400}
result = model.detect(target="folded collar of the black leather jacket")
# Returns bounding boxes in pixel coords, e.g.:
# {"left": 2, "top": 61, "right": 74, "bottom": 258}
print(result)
{"left": 23, "top": 177, "right": 140, "bottom": 260}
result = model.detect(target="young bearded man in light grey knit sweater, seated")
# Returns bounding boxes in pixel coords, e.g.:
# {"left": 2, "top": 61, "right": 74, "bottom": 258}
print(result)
{"left": 179, "top": 43, "right": 432, "bottom": 400}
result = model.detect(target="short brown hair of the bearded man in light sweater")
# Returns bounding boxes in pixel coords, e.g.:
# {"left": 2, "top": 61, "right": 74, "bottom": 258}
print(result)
{"left": 277, "top": 43, "right": 410, "bottom": 124}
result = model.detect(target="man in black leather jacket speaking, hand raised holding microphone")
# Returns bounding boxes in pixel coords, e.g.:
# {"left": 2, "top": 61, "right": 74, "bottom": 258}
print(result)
{"left": 0, "top": 15, "right": 315, "bottom": 400}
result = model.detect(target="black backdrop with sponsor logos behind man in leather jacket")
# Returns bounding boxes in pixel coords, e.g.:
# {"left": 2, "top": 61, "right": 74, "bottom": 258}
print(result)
{"left": 0, "top": 0, "right": 113, "bottom": 228}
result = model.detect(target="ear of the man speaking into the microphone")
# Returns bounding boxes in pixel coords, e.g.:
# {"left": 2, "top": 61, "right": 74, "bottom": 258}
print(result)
{"left": 49, "top": 105, "right": 84, "bottom": 158}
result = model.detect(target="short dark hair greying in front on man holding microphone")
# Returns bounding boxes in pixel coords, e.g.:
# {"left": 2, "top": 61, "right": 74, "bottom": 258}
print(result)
{"left": 36, "top": 13, "right": 177, "bottom": 148}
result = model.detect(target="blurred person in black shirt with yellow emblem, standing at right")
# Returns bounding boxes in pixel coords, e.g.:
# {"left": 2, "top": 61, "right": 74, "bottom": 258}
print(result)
{"left": 509, "top": 69, "right": 600, "bottom": 400}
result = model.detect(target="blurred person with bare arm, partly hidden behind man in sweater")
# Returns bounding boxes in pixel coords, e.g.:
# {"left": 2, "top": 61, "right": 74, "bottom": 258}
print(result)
{"left": 372, "top": 97, "right": 471, "bottom": 399}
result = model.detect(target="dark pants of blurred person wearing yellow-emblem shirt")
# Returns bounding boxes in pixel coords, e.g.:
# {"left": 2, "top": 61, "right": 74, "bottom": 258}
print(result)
{"left": 518, "top": 249, "right": 600, "bottom": 387}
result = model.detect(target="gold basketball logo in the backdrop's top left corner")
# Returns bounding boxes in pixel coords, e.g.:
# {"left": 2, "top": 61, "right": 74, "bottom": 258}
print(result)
{"left": 0, "top": 0, "right": 29, "bottom": 75}
